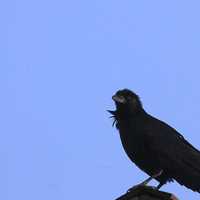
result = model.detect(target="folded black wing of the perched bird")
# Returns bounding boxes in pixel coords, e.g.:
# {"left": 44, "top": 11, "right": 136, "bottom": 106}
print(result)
{"left": 145, "top": 117, "right": 200, "bottom": 192}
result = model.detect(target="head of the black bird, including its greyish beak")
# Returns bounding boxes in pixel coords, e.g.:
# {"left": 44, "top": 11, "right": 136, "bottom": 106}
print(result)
{"left": 112, "top": 89, "right": 143, "bottom": 115}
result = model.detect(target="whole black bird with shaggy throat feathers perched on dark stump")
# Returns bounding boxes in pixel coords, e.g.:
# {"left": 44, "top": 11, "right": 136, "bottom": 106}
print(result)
{"left": 109, "top": 89, "right": 200, "bottom": 192}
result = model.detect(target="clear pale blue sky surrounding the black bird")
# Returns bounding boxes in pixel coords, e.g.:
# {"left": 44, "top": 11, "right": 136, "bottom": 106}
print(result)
{"left": 0, "top": 0, "right": 200, "bottom": 200}
